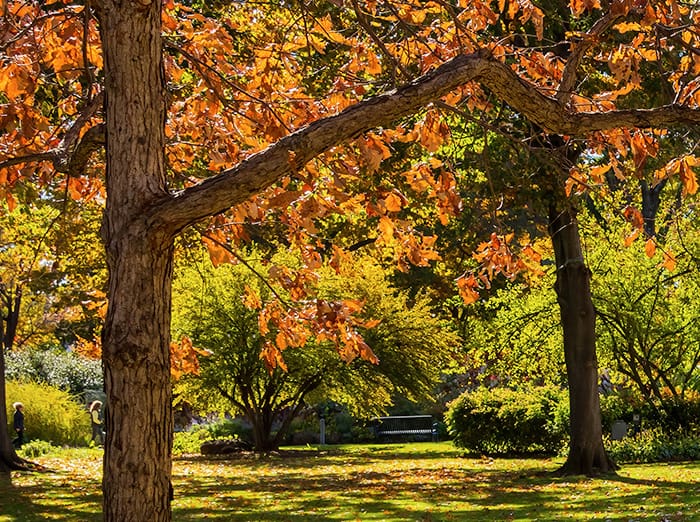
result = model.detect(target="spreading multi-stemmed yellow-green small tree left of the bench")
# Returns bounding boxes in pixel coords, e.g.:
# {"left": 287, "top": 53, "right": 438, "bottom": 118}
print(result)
{"left": 173, "top": 248, "right": 457, "bottom": 451}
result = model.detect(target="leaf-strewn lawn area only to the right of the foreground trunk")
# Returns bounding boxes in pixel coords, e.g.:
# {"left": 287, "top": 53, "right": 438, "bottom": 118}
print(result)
{"left": 170, "top": 445, "right": 700, "bottom": 522}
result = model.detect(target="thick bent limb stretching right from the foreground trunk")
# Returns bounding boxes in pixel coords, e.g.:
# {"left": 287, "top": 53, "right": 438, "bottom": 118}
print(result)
{"left": 156, "top": 52, "right": 700, "bottom": 234}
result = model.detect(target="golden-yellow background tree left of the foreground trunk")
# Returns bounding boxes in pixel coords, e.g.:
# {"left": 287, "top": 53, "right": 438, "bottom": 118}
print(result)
{"left": 0, "top": 194, "right": 105, "bottom": 469}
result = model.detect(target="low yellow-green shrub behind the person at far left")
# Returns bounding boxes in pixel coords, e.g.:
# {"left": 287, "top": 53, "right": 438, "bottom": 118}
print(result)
{"left": 7, "top": 381, "right": 91, "bottom": 446}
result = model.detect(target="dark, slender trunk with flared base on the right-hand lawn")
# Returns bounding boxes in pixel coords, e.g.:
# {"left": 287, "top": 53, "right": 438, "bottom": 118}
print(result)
{"left": 549, "top": 201, "right": 615, "bottom": 475}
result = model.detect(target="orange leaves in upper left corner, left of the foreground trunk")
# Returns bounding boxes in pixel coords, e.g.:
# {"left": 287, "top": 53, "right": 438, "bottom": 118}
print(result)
{"left": 0, "top": 1, "right": 103, "bottom": 208}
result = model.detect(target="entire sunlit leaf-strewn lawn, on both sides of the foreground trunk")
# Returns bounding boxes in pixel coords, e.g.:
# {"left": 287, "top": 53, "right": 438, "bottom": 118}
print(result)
{"left": 0, "top": 443, "right": 700, "bottom": 522}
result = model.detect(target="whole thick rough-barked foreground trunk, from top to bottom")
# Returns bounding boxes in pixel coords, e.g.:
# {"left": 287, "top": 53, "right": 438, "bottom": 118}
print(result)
{"left": 101, "top": 0, "right": 175, "bottom": 522}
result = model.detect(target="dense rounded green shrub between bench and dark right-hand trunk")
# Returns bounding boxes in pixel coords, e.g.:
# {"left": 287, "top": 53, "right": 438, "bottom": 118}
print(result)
{"left": 445, "top": 387, "right": 568, "bottom": 455}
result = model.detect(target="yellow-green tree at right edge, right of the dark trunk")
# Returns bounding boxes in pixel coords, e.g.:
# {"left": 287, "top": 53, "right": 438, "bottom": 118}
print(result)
{"left": 590, "top": 203, "right": 700, "bottom": 409}
